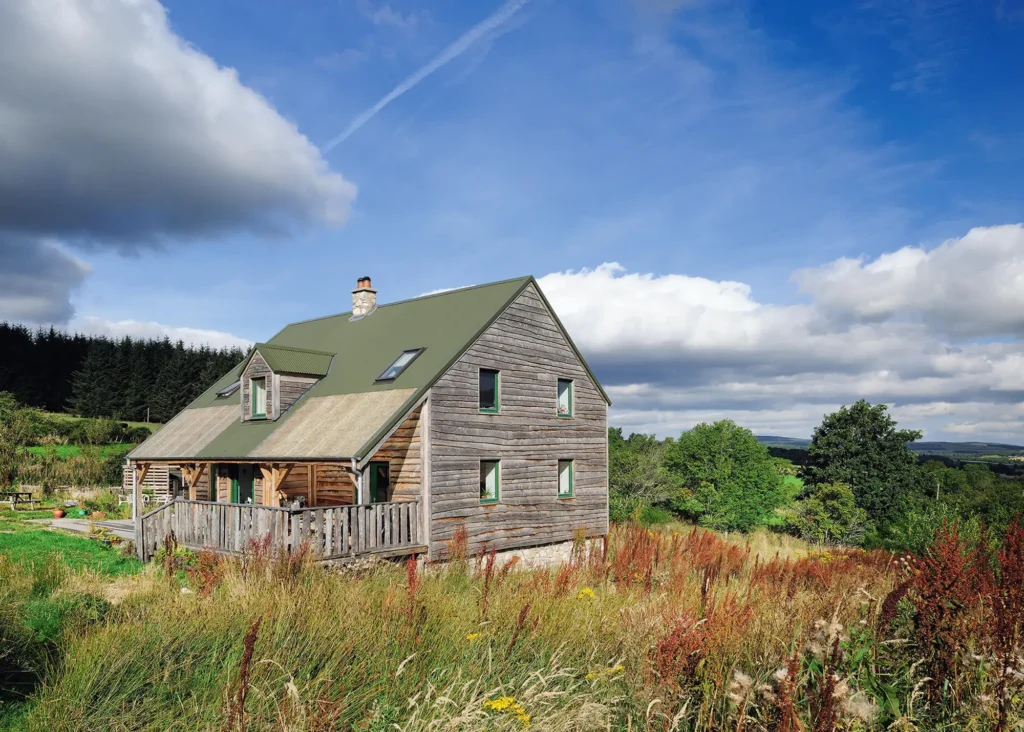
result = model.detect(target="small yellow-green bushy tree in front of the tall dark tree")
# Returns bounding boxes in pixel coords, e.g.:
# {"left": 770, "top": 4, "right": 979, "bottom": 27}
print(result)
{"left": 786, "top": 483, "right": 867, "bottom": 545}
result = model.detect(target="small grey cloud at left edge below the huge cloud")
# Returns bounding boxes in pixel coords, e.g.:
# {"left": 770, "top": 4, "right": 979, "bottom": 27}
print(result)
{"left": 0, "top": 237, "right": 89, "bottom": 322}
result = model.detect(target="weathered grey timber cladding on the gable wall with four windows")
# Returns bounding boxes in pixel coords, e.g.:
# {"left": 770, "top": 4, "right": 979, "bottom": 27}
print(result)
{"left": 429, "top": 285, "right": 608, "bottom": 556}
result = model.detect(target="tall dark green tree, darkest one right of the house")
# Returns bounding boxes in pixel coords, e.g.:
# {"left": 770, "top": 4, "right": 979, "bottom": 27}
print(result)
{"left": 805, "top": 399, "right": 921, "bottom": 526}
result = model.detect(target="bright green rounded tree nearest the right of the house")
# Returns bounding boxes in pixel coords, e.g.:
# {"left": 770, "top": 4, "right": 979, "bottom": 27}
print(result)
{"left": 665, "top": 420, "right": 782, "bottom": 531}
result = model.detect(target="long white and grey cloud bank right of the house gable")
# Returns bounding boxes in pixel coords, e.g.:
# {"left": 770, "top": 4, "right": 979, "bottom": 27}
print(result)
{"left": 540, "top": 226, "right": 1024, "bottom": 441}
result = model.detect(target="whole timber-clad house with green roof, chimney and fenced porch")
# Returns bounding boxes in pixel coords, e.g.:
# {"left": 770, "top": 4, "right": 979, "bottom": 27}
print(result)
{"left": 128, "top": 277, "right": 610, "bottom": 559}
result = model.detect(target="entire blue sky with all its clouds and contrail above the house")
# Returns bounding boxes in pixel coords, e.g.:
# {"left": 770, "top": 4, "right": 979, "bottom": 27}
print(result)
{"left": 0, "top": 0, "right": 1024, "bottom": 444}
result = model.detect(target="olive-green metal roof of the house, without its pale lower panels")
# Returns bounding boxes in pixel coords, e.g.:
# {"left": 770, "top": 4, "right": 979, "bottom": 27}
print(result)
{"left": 130, "top": 276, "right": 610, "bottom": 459}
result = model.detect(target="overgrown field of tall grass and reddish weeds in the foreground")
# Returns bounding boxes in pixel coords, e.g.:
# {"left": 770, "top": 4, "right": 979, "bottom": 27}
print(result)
{"left": 0, "top": 509, "right": 1024, "bottom": 732}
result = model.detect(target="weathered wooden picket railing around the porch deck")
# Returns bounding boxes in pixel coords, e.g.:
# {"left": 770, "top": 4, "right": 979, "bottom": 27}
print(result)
{"left": 136, "top": 499, "right": 421, "bottom": 561}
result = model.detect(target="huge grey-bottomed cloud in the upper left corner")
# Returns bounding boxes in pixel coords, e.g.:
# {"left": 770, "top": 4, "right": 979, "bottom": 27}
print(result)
{"left": 0, "top": 0, "right": 355, "bottom": 249}
